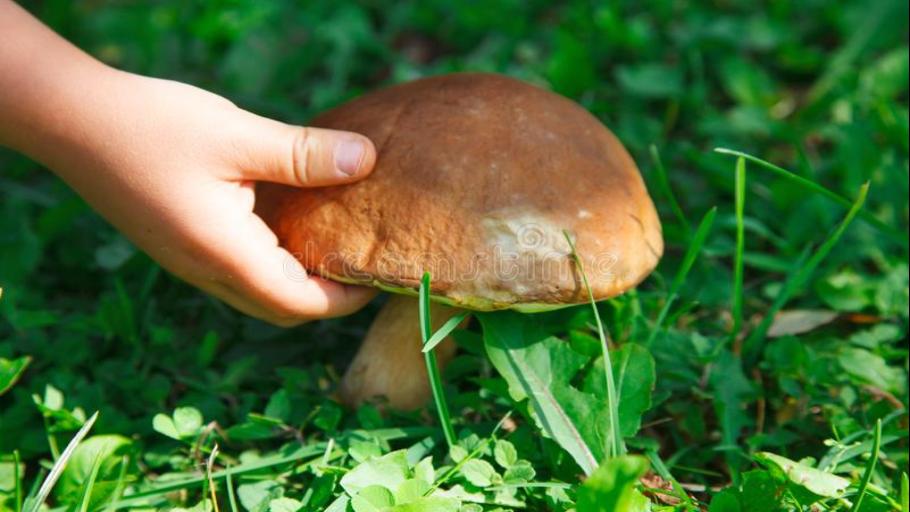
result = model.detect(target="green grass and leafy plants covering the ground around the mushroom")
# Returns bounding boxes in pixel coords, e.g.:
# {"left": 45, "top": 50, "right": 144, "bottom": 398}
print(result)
{"left": 0, "top": 0, "right": 910, "bottom": 512}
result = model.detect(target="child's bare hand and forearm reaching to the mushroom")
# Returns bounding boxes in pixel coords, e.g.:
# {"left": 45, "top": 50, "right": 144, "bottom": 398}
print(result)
{"left": 0, "top": 0, "right": 376, "bottom": 326}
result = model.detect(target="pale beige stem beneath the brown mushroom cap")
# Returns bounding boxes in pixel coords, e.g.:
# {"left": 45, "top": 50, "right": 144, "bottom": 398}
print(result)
{"left": 340, "top": 294, "right": 458, "bottom": 410}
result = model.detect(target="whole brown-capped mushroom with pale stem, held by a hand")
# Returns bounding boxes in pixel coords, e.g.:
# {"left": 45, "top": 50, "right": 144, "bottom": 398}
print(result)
{"left": 257, "top": 73, "right": 663, "bottom": 409}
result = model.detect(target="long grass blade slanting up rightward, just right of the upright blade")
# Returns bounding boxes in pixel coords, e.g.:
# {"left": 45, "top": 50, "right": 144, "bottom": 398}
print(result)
{"left": 743, "top": 182, "right": 869, "bottom": 361}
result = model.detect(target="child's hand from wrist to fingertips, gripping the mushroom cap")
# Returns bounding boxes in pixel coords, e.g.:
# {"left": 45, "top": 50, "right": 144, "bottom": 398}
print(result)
{"left": 68, "top": 73, "right": 375, "bottom": 324}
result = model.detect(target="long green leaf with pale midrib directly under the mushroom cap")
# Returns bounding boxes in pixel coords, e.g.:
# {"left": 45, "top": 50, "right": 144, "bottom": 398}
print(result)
{"left": 477, "top": 311, "right": 610, "bottom": 474}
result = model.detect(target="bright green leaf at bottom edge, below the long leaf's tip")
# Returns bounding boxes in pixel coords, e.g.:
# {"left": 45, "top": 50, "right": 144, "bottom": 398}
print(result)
{"left": 576, "top": 455, "right": 651, "bottom": 512}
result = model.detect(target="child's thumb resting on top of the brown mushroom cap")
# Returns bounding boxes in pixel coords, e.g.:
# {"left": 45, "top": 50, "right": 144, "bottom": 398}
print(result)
{"left": 237, "top": 112, "right": 376, "bottom": 187}
